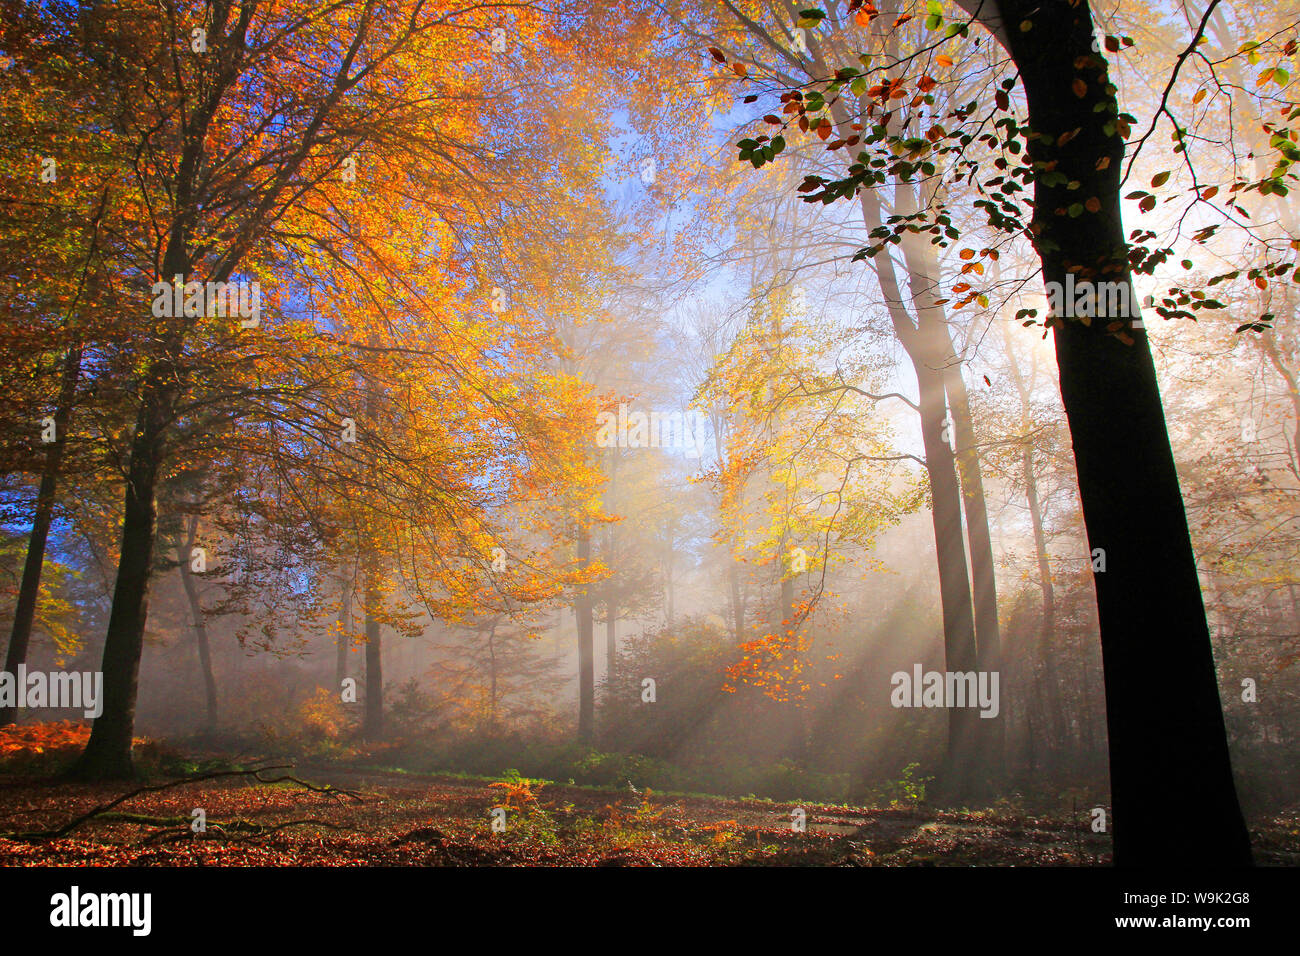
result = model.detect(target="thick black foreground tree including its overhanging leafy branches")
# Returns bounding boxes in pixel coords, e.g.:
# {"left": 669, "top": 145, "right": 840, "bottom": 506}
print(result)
{"left": 717, "top": 0, "right": 1288, "bottom": 865}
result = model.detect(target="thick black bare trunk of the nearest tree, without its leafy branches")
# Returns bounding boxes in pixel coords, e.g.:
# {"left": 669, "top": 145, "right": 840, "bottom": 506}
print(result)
{"left": 967, "top": 0, "right": 1251, "bottom": 866}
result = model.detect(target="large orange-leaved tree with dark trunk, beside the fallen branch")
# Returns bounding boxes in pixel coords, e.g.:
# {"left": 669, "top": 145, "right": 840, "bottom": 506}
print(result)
{"left": 31, "top": 3, "right": 624, "bottom": 778}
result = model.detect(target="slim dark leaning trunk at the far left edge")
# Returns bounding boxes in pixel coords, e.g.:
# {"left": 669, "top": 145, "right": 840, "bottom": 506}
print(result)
{"left": 0, "top": 346, "right": 82, "bottom": 727}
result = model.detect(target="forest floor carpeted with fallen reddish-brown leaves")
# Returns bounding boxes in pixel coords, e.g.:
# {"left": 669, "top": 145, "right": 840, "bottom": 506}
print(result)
{"left": 0, "top": 763, "right": 1300, "bottom": 866}
